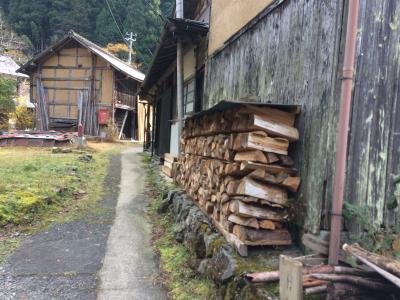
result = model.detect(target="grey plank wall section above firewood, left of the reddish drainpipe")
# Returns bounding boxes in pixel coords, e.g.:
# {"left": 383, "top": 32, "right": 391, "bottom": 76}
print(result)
{"left": 203, "top": 0, "right": 343, "bottom": 233}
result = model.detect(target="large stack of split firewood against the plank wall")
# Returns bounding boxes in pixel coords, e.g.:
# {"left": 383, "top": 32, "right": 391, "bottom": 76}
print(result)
{"left": 176, "top": 106, "right": 300, "bottom": 245}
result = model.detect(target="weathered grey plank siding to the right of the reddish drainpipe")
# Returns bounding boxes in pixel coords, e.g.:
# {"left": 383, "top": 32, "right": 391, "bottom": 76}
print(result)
{"left": 346, "top": 0, "right": 400, "bottom": 229}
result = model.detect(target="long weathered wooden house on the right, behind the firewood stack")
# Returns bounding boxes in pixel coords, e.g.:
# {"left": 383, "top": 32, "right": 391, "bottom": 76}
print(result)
{"left": 142, "top": 0, "right": 400, "bottom": 239}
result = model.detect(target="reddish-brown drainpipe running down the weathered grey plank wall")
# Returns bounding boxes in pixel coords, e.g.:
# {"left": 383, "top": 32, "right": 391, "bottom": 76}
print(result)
{"left": 328, "top": 0, "right": 359, "bottom": 265}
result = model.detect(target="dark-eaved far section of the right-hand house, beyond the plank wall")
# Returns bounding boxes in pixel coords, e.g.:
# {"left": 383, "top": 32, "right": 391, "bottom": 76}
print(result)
{"left": 141, "top": 0, "right": 210, "bottom": 156}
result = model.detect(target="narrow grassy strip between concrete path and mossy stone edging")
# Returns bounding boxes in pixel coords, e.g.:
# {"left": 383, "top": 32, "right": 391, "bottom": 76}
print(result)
{"left": 142, "top": 154, "right": 215, "bottom": 300}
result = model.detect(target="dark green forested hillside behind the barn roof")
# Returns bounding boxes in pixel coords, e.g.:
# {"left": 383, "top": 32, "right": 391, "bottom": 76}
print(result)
{"left": 0, "top": 0, "right": 174, "bottom": 70}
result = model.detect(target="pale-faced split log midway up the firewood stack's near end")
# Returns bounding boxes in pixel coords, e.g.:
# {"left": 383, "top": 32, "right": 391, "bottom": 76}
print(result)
{"left": 236, "top": 177, "right": 288, "bottom": 205}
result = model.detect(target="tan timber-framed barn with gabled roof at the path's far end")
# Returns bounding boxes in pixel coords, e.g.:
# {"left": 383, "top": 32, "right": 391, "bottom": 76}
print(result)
{"left": 19, "top": 31, "right": 144, "bottom": 139}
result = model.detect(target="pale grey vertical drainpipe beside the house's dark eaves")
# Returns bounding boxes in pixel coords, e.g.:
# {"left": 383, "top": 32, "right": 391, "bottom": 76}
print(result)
{"left": 176, "top": 0, "right": 183, "bottom": 154}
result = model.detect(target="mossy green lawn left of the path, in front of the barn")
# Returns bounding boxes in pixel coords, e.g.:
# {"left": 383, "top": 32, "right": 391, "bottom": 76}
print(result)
{"left": 0, "top": 143, "right": 124, "bottom": 263}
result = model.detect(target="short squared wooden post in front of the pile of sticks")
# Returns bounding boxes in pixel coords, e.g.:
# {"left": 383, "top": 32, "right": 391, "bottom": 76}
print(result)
{"left": 279, "top": 255, "right": 303, "bottom": 300}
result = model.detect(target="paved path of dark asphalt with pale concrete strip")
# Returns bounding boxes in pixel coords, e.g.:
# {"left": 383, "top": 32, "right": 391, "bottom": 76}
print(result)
{"left": 0, "top": 148, "right": 167, "bottom": 300}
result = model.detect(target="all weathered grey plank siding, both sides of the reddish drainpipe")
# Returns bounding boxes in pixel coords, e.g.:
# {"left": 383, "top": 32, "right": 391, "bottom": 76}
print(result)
{"left": 203, "top": 0, "right": 400, "bottom": 233}
